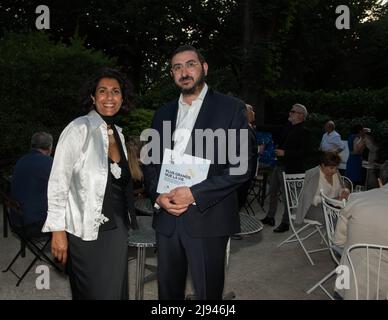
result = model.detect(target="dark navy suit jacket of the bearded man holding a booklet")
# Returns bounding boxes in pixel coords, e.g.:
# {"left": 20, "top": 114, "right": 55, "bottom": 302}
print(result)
{"left": 144, "top": 89, "right": 250, "bottom": 237}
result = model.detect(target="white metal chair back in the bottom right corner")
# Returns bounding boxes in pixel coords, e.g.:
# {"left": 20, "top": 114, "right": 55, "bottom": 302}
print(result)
{"left": 345, "top": 243, "right": 388, "bottom": 300}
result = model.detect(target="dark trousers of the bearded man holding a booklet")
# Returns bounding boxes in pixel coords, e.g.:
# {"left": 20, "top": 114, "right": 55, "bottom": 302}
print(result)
{"left": 156, "top": 217, "right": 229, "bottom": 300}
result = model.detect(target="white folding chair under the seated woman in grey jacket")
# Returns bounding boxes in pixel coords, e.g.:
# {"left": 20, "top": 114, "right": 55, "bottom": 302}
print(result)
{"left": 278, "top": 172, "right": 328, "bottom": 265}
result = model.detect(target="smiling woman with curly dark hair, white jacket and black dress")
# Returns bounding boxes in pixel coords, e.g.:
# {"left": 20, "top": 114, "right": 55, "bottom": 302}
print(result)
{"left": 42, "top": 68, "right": 137, "bottom": 300}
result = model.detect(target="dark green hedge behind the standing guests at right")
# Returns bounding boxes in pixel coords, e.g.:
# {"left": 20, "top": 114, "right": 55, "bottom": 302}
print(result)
{"left": 268, "top": 87, "right": 388, "bottom": 161}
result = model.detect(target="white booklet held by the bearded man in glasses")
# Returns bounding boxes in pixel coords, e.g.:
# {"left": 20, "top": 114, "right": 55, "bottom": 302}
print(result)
{"left": 157, "top": 149, "right": 211, "bottom": 193}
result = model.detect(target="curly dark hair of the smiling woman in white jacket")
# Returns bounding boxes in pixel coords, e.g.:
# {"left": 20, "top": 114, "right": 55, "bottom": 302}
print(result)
{"left": 80, "top": 68, "right": 134, "bottom": 112}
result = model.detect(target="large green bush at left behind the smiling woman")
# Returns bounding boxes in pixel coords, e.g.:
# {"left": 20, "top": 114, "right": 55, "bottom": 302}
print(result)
{"left": 0, "top": 32, "right": 115, "bottom": 158}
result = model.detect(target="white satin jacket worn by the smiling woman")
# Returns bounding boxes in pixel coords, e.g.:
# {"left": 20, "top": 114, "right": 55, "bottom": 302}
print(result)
{"left": 42, "top": 110, "right": 128, "bottom": 240}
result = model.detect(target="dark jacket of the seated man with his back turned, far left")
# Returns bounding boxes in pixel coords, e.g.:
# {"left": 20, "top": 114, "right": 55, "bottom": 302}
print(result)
{"left": 11, "top": 150, "right": 53, "bottom": 225}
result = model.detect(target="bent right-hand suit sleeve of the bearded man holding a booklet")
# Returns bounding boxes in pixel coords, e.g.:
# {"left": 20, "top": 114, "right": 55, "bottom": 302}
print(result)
{"left": 190, "top": 104, "right": 254, "bottom": 212}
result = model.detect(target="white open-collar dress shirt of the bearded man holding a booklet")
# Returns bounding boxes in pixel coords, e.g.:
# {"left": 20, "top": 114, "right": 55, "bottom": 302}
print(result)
{"left": 173, "top": 83, "right": 208, "bottom": 154}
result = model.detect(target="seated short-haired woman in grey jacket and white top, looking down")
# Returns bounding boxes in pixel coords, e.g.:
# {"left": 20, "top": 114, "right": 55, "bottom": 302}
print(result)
{"left": 296, "top": 152, "right": 350, "bottom": 224}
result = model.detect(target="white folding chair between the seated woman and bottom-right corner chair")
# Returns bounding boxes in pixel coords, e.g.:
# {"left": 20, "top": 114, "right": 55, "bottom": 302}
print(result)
{"left": 307, "top": 190, "right": 346, "bottom": 300}
